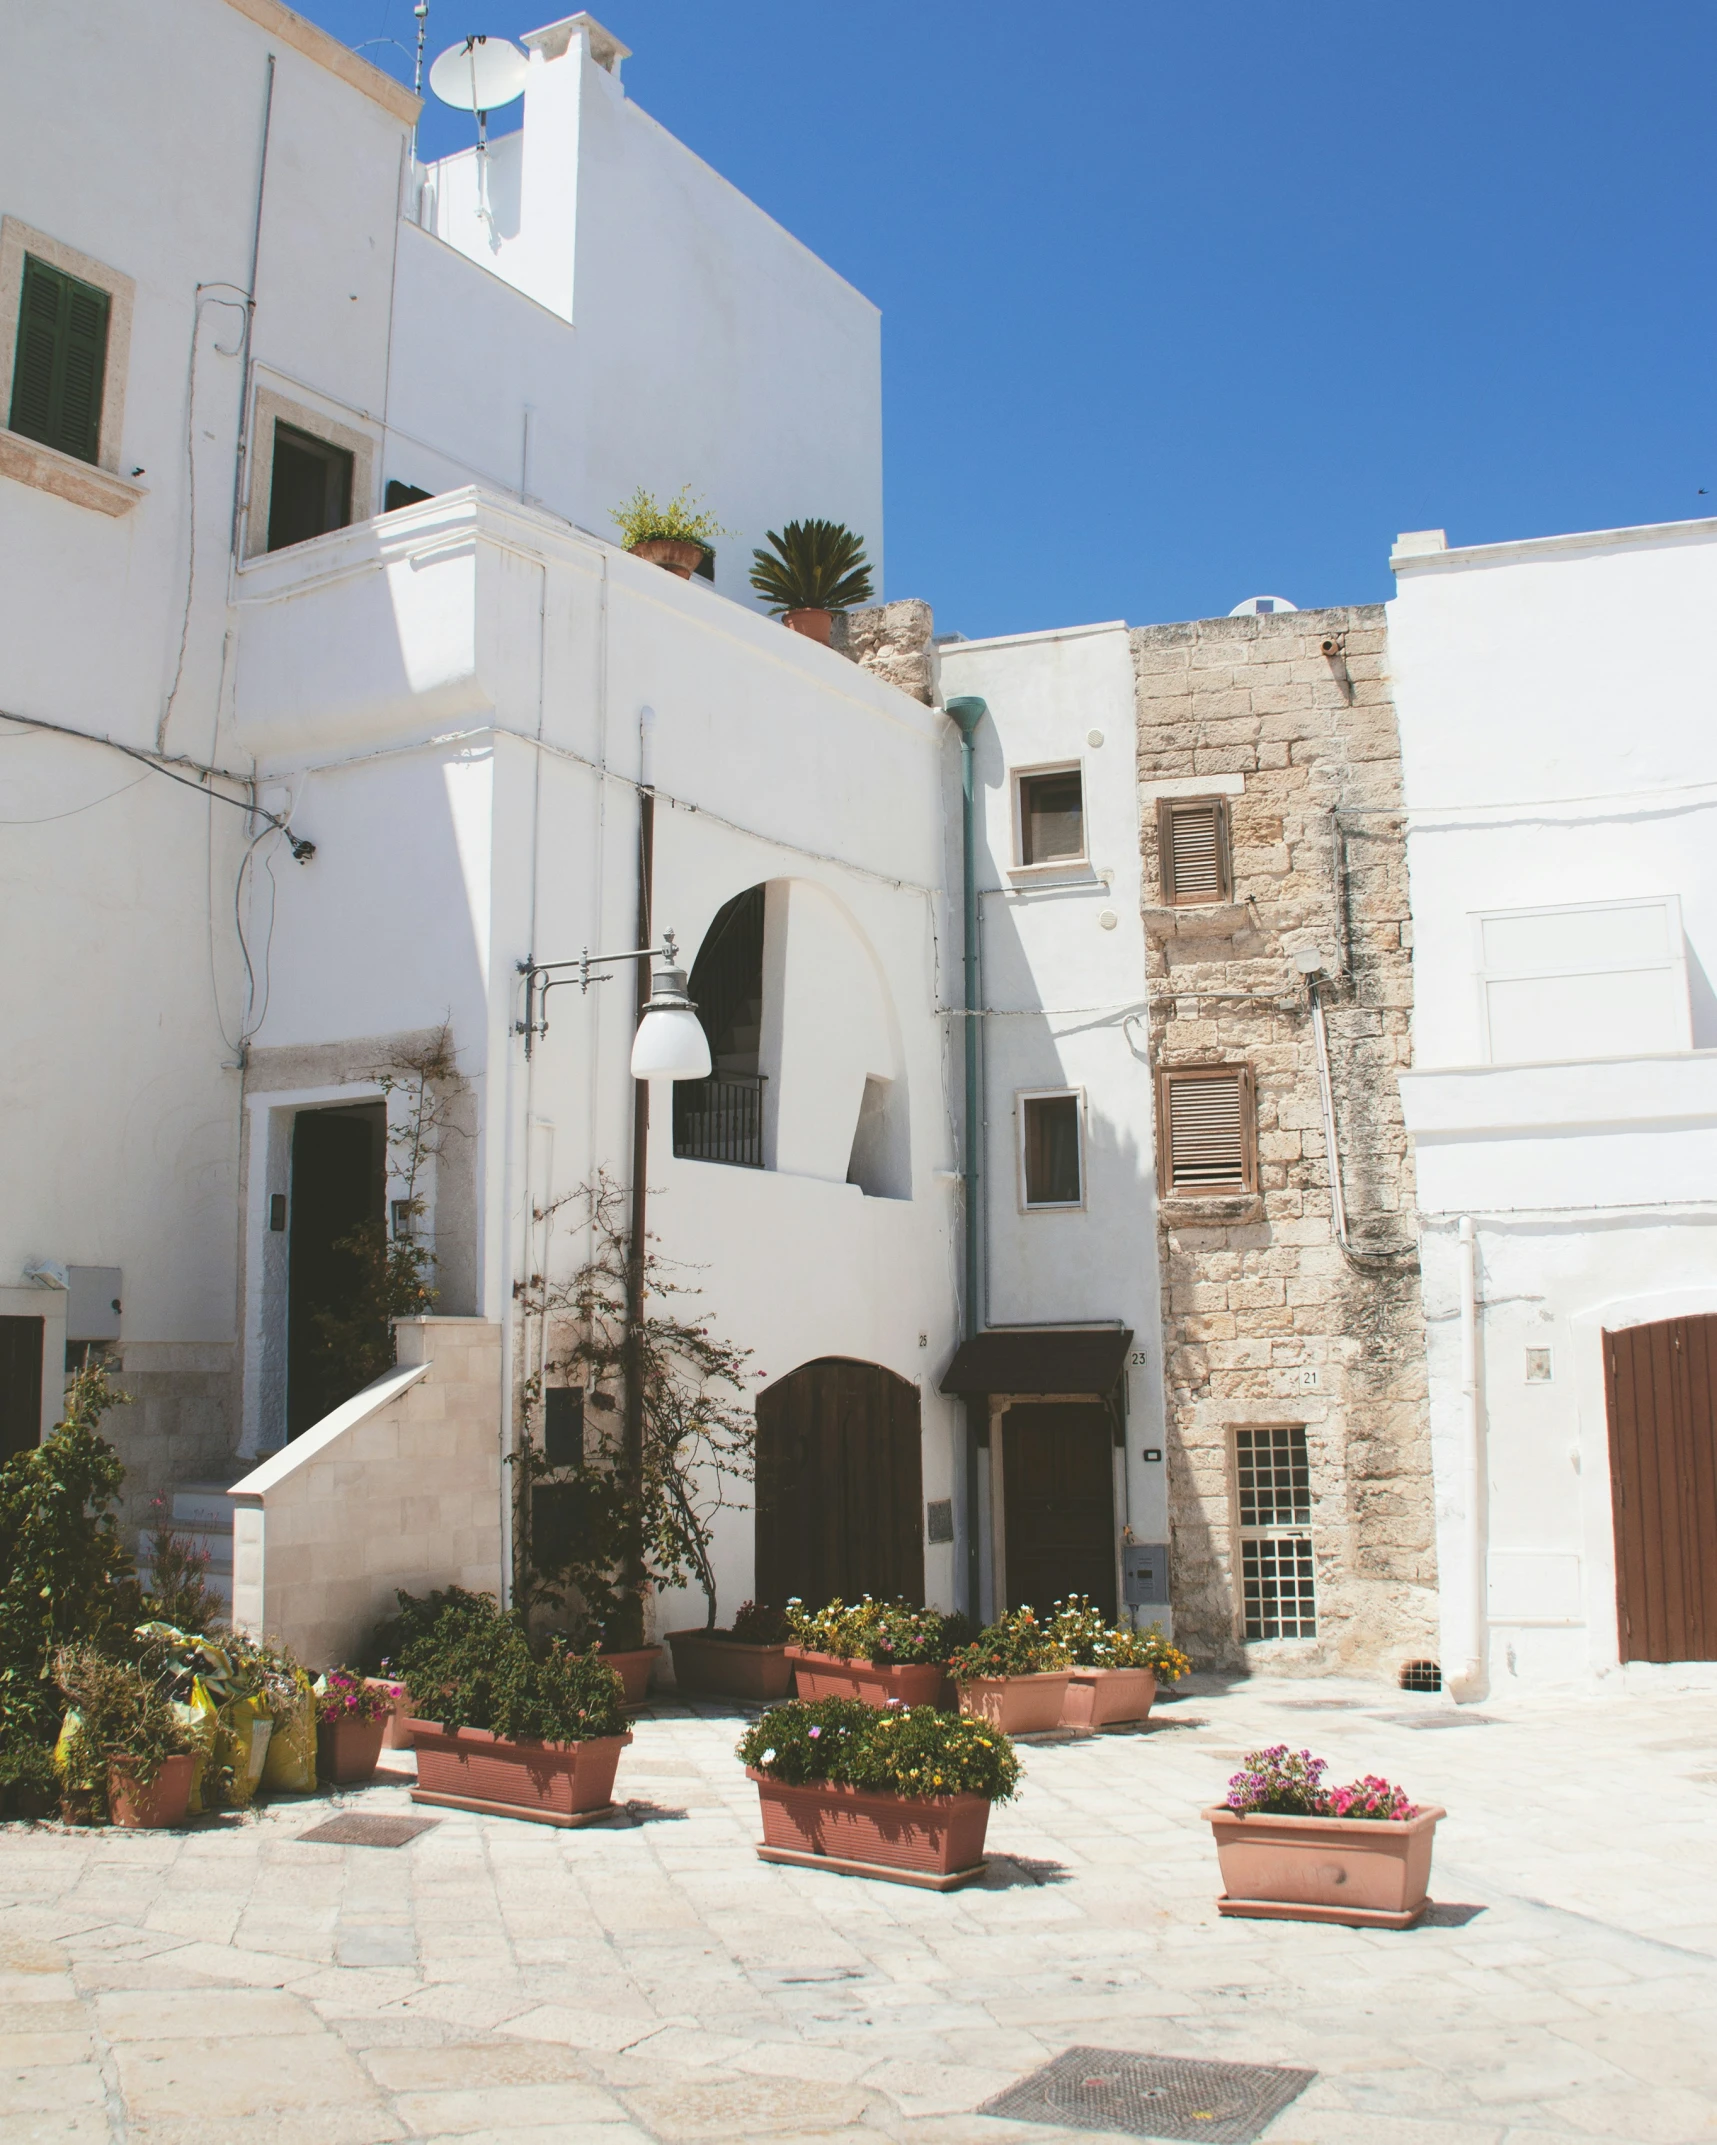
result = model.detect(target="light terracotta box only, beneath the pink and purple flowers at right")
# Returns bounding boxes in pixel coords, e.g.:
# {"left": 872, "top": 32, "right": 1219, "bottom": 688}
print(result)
{"left": 1204, "top": 1804, "right": 1447, "bottom": 1928}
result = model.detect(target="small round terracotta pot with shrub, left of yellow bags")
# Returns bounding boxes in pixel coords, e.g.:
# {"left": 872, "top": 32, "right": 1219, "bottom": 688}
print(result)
{"left": 54, "top": 1645, "right": 195, "bottom": 1828}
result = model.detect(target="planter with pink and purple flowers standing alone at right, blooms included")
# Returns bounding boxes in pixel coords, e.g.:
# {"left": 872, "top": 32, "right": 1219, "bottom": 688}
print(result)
{"left": 1204, "top": 1744, "right": 1447, "bottom": 1928}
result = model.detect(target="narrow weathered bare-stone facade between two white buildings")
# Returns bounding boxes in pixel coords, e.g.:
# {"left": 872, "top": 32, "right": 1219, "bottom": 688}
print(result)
{"left": 1133, "top": 605, "right": 1436, "bottom": 1671}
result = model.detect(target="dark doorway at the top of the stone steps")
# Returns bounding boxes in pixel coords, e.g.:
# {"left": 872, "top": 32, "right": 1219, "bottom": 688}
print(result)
{"left": 285, "top": 1103, "right": 386, "bottom": 1437}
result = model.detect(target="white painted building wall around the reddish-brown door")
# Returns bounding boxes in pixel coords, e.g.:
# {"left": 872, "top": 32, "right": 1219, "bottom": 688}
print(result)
{"left": 1389, "top": 521, "right": 1717, "bottom": 1688}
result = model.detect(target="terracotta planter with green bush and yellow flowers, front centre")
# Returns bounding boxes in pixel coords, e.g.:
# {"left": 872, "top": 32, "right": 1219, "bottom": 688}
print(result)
{"left": 738, "top": 1699, "right": 1019, "bottom": 1892}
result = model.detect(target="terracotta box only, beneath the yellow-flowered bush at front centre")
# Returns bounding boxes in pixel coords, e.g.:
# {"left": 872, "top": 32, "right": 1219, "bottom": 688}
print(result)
{"left": 745, "top": 1765, "right": 989, "bottom": 1892}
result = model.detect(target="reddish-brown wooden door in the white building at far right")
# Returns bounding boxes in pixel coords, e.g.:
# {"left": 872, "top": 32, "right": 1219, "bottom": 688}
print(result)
{"left": 1603, "top": 1317, "right": 1717, "bottom": 1660}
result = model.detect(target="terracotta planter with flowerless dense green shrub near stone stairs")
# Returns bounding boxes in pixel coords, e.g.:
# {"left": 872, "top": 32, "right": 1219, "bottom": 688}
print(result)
{"left": 397, "top": 1587, "right": 631, "bottom": 1825}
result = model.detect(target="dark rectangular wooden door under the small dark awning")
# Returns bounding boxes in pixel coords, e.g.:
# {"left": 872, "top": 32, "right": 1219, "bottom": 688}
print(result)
{"left": 1002, "top": 1401, "right": 1116, "bottom": 1622}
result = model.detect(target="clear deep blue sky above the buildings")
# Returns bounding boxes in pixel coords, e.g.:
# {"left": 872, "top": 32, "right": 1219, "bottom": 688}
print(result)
{"left": 300, "top": 0, "right": 1717, "bottom": 635}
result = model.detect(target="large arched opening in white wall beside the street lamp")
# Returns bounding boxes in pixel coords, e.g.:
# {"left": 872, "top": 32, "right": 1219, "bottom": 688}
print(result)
{"left": 674, "top": 879, "right": 912, "bottom": 1199}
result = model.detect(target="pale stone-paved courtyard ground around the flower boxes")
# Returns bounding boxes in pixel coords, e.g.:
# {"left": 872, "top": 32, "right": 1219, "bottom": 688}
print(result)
{"left": 0, "top": 1682, "right": 1717, "bottom": 2145}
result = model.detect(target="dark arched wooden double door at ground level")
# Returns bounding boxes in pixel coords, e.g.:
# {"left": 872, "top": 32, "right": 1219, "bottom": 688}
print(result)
{"left": 755, "top": 1356, "right": 925, "bottom": 1609}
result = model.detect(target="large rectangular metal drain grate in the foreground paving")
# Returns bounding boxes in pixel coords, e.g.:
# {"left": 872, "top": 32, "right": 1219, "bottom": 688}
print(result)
{"left": 979, "top": 2048, "right": 1318, "bottom": 2145}
